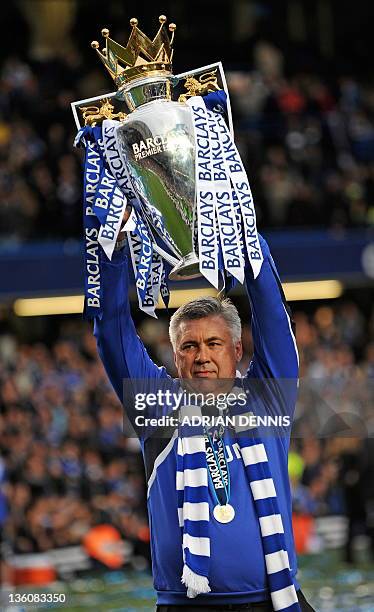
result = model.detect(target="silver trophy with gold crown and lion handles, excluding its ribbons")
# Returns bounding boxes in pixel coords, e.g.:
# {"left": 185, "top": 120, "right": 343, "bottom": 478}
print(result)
{"left": 72, "top": 15, "right": 232, "bottom": 280}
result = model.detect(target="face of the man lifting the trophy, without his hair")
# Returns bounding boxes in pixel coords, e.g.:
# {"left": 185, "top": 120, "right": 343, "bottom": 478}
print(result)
{"left": 174, "top": 315, "right": 243, "bottom": 391}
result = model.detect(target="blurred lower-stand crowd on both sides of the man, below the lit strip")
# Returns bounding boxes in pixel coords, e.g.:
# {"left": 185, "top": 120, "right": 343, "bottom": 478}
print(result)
{"left": 0, "top": 302, "right": 374, "bottom": 552}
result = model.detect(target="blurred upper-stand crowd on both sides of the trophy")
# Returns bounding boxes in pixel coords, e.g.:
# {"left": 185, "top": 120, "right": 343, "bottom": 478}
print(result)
{"left": 0, "top": 43, "right": 374, "bottom": 241}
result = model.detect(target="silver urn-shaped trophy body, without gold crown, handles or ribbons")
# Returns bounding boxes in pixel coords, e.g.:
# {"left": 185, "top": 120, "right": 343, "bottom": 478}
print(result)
{"left": 117, "top": 77, "right": 199, "bottom": 280}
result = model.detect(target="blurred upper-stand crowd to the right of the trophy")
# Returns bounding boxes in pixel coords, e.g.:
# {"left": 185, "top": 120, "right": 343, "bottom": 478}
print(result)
{"left": 228, "top": 52, "right": 374, "bottom": 228}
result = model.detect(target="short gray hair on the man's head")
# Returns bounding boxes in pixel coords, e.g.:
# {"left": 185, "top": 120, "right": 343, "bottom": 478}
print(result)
{"left": 169, "top": 297, "right": 242, "bottom": 350}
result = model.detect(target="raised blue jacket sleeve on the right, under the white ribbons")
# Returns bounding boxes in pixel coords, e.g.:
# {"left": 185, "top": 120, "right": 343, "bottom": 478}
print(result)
{"left": 246, "top": 236, "right": 299, "bottom": 413}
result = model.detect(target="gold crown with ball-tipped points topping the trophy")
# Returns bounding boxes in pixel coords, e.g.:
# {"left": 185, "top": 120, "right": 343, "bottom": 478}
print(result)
{"left": 91, "top": 15, "right": 177, "bottom": 89}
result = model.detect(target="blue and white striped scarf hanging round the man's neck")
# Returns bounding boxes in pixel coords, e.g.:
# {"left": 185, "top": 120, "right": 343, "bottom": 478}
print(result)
{"left": 176, "top": 406, "right": 301, "bottom": 612}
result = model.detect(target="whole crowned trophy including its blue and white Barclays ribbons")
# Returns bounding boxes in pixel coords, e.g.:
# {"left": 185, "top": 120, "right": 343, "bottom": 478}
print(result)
{"left": 72, "top": 15, "right": 263, "bottom": 318}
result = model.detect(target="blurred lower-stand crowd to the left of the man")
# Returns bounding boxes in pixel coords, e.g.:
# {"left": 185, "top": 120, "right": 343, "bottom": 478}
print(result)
{"left": 0, "top": 323, "right": 148, "bottom": 552}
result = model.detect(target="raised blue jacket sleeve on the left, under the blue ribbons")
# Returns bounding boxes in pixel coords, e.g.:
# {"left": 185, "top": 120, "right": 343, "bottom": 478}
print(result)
{"left": 94, "top": 253, "right": 170, "bottom": 420}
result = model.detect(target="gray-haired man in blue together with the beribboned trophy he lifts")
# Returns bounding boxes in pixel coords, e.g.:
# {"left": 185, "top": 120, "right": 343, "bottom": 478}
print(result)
{"left": 76, "top": 16, "right": 312, "bottom": 612}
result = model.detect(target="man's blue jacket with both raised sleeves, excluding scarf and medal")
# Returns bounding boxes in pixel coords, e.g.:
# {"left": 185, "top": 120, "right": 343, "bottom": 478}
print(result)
{"left": 95, "top": 238, "right": 299, "bottom": 605}
